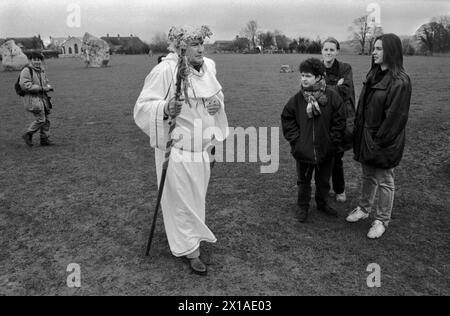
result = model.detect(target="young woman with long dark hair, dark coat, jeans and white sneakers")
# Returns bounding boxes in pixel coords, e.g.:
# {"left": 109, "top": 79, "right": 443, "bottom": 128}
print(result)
{"left": 347, "top": 34, "right": 412, "bottom": 239}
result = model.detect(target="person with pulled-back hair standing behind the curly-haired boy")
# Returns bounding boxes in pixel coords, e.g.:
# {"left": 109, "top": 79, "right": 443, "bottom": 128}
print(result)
{"left": 322, "top": 37, "right": 355, "bottom": 203}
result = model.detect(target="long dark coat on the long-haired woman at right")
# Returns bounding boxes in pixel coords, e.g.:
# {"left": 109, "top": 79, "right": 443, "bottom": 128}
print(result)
{"left": 353, "top": 71, "right": 411, "bottom": 169}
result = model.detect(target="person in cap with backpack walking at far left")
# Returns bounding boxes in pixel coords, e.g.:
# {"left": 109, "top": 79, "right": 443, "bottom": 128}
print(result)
{"left": 19, "top": 52, "right": 53, "bottom": 147}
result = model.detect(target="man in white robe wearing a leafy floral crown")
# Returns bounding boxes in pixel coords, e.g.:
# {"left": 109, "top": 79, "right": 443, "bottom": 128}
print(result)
{"left": 134, "top": 26, "right": 228, "bottom": 275}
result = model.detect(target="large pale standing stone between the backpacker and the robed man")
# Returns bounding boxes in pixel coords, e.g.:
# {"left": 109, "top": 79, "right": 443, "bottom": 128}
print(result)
{"left": 82, "top": 33, "right": 110, "bottom": 68}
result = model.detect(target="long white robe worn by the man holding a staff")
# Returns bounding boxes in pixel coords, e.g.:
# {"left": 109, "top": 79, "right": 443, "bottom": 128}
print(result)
{"left": 134, "top": 53, "right": 228, "bottom": 257}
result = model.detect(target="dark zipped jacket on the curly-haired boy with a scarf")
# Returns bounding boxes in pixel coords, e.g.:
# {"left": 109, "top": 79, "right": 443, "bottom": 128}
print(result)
{"left": 281, "top": 87, "right": 345, "bottom": 164}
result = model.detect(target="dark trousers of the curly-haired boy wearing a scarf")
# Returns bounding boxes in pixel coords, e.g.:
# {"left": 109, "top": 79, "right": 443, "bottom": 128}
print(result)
{"left": 297, "top": 159, "right": 333, "bottom": 209}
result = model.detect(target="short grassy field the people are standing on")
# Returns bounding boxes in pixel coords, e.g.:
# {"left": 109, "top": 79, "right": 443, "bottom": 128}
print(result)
{"left": 0, "top": 55, "right": 450, "bottom": 295}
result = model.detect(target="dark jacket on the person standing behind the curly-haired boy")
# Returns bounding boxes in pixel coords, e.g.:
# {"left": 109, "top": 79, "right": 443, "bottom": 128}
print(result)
{"left": 325, "top": 60, "right": 356, "bottom": 152}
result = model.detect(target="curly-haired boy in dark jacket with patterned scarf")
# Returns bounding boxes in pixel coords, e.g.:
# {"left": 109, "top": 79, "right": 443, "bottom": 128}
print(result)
{"left": 281, "top": 58, "right": 346, "bottom": 222}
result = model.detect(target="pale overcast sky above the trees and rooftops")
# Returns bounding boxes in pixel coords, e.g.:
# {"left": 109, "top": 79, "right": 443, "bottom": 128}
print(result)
{"left": 0, "top": 0, "right": 450, "bottom": 41}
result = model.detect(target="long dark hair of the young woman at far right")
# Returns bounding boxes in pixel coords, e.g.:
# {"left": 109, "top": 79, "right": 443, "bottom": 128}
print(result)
{"left": 369, "top": 33, "right": 406, "bottom": 78}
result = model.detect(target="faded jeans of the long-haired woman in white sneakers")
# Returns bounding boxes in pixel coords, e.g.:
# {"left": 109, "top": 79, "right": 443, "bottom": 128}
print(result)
{"left": 359, "top": 164, "right": 395, "bottom": 227}
